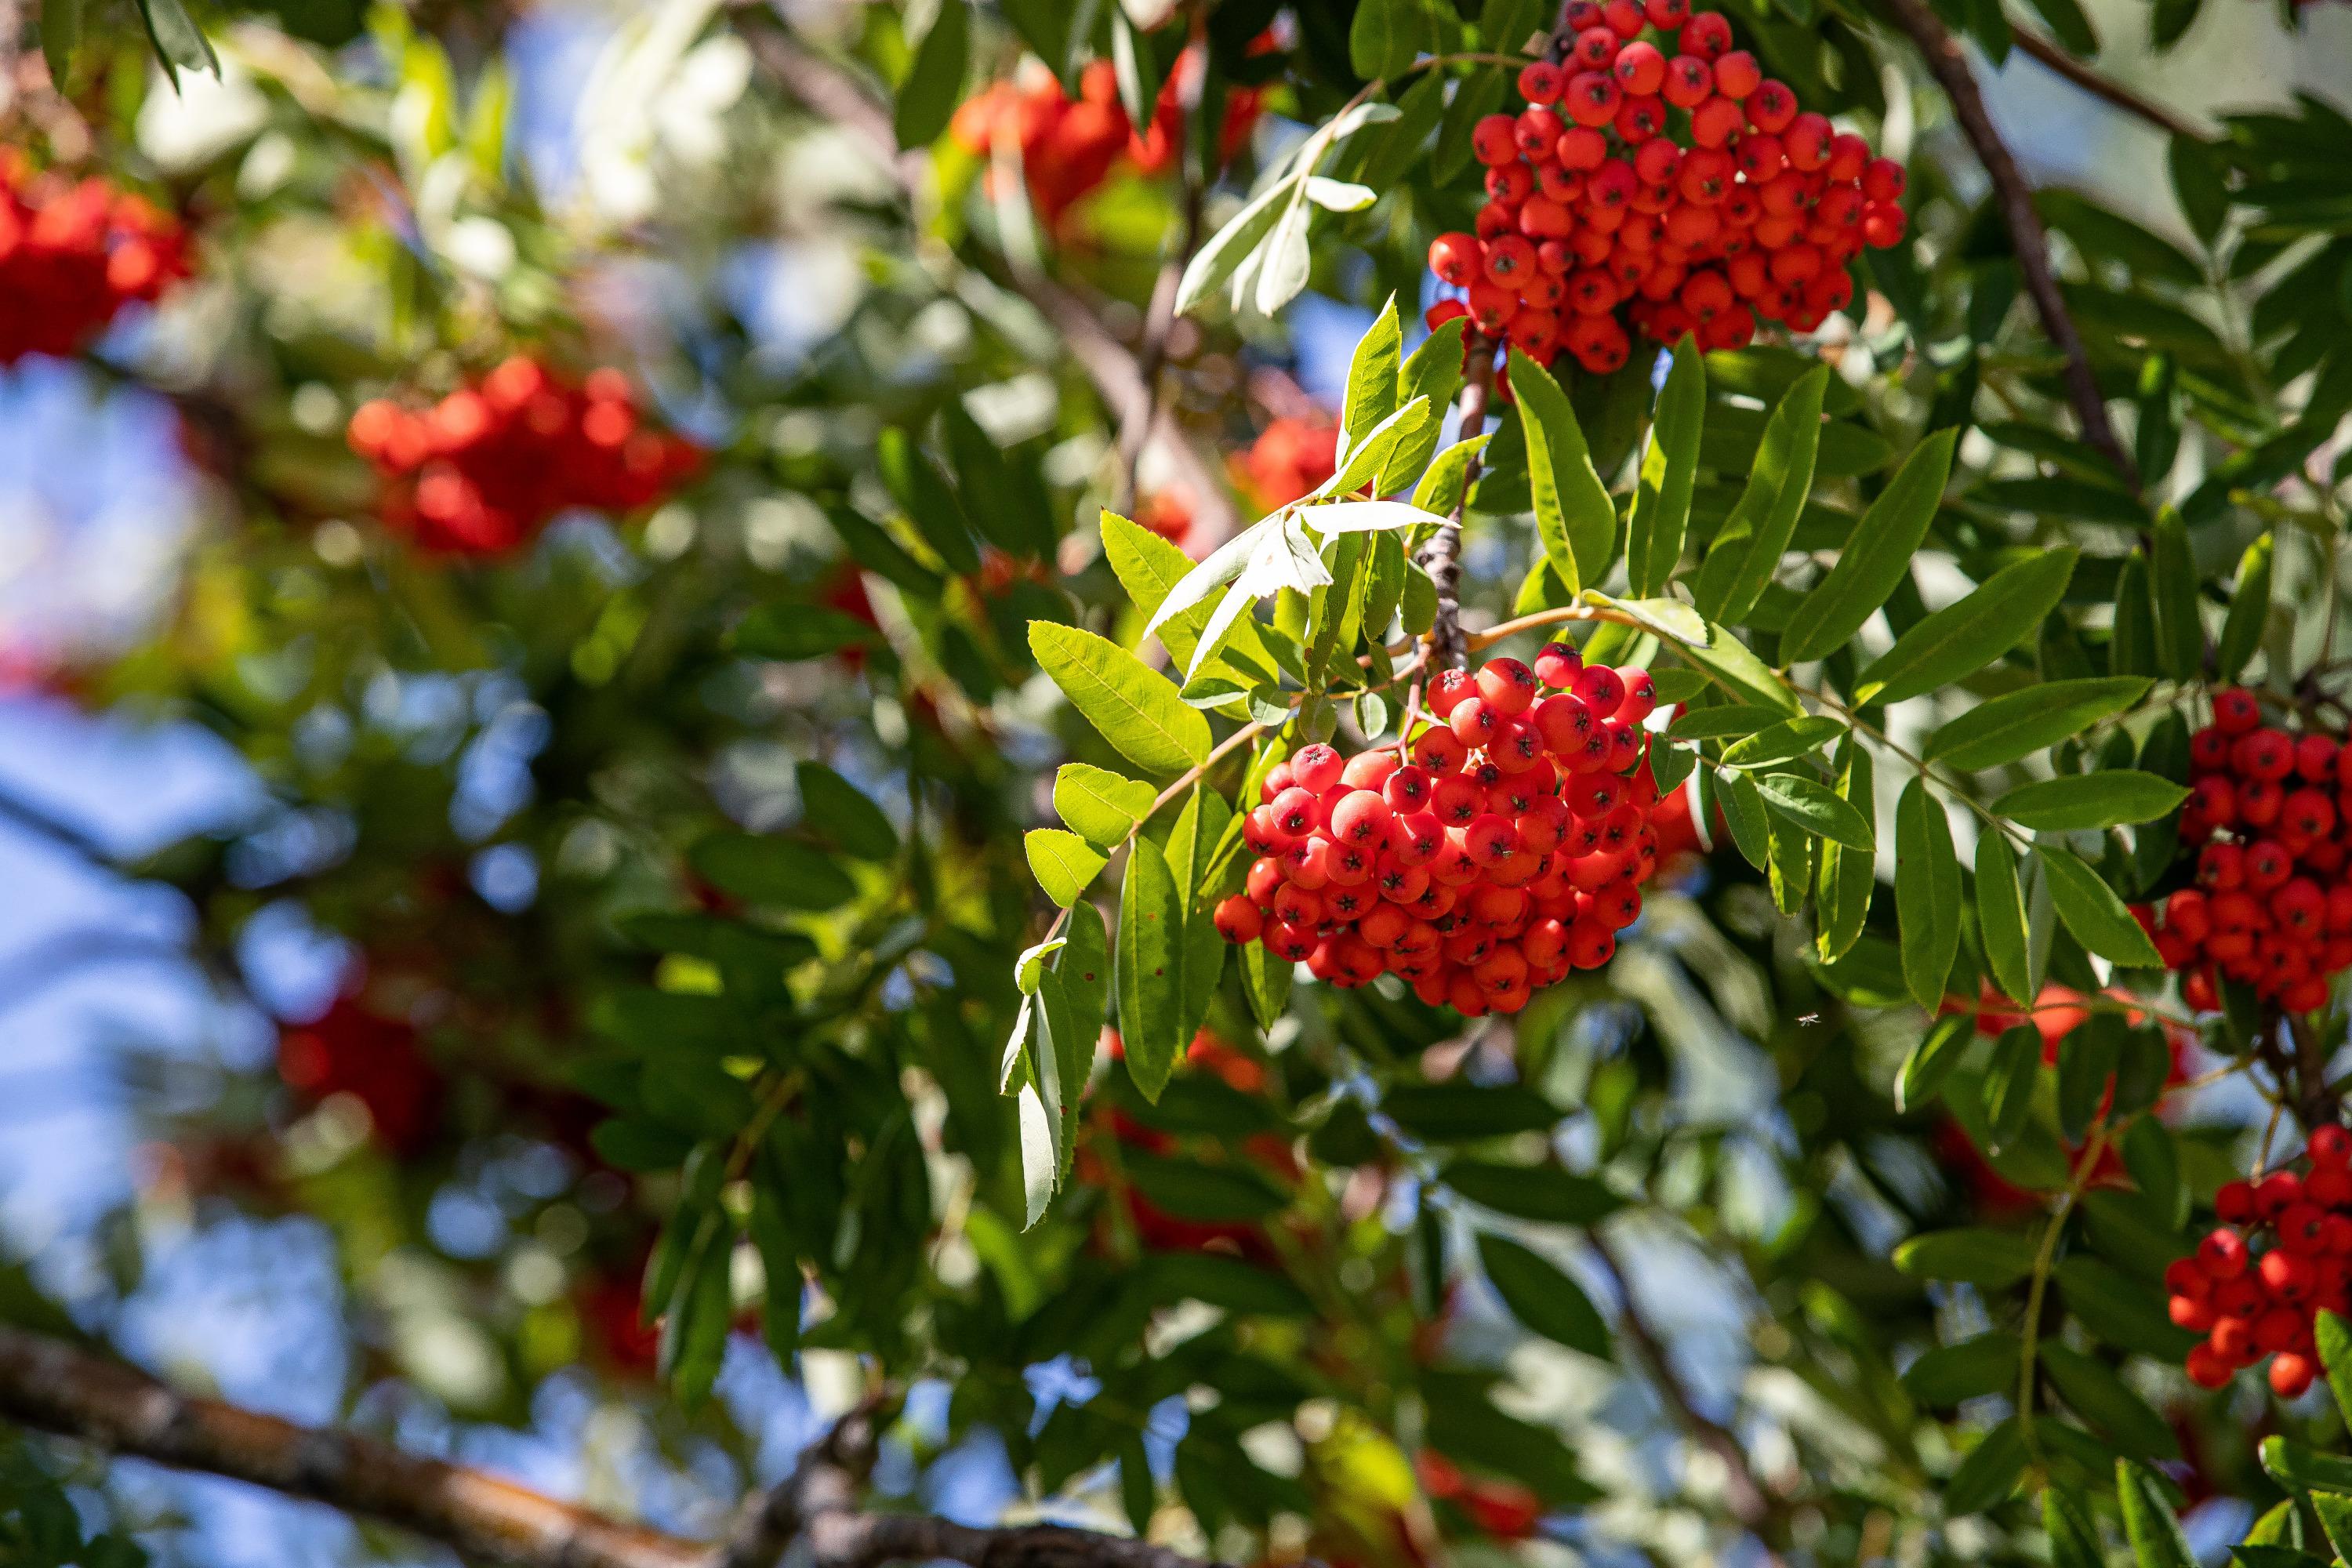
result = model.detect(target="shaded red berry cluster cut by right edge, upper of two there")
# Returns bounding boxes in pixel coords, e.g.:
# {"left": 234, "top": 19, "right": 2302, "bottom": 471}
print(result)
{"left": 2133, "top": 687, "right": 2352, "bottom": 1013}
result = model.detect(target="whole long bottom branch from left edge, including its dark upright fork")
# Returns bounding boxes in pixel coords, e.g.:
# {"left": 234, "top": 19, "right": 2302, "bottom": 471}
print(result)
{"left": 0, "top": 1326, "right": 1223, "bottom": 1568}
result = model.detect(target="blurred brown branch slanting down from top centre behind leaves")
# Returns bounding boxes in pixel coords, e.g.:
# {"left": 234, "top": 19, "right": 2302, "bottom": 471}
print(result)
{"left": 736, "top": 2, "right": 1242, "bottom": 541}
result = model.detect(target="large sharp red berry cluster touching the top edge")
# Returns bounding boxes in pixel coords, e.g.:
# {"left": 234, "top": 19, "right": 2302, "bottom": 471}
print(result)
{"left": 1428, "top": 0, "right": 1903, "bottom": 374}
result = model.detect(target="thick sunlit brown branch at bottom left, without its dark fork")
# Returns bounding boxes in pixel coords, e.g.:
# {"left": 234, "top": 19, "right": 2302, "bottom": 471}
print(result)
{"left": 0, "top": 1328, "right": 708, "bottom": 1568}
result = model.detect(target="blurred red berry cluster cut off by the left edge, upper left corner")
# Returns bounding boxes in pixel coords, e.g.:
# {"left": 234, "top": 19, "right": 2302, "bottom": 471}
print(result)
{"left": 0, "top": 148, "right": 188, "bottom": 365}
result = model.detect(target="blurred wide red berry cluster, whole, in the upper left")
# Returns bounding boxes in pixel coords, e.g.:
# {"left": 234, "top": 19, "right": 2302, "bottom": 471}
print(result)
{"left": 348, "top": 355, "right": 703, "bottom": 555}
